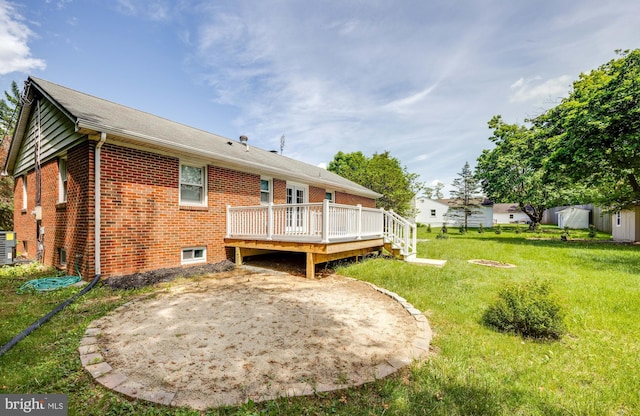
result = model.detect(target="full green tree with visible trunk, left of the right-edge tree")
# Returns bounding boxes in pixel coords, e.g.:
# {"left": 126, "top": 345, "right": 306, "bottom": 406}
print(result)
{"left": 476, "top": 115, "right": 586, "bottom": 229}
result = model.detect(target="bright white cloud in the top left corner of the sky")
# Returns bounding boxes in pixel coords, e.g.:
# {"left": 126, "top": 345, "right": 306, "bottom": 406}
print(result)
{"left": 0, "top": 0, "right": 46, "bottom": 75}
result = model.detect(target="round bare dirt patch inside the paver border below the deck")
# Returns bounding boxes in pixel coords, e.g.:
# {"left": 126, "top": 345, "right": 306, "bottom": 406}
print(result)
{"left": 92, "top": 269, "right": 430, "bottom": 409}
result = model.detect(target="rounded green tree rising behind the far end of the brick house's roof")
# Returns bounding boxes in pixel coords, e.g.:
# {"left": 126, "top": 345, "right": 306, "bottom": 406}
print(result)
{"left": 327, "top": 151, "right": 424, "bottom": 216}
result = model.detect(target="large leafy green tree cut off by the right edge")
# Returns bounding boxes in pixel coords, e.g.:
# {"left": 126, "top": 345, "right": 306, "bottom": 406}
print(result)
{"left": 534, "top": 49, "right": 640, "bottom": 210}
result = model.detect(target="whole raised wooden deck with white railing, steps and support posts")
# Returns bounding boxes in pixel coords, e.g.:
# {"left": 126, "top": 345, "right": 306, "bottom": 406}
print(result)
{"left": 224, "top": 200, "right": 416, "bottom": 278}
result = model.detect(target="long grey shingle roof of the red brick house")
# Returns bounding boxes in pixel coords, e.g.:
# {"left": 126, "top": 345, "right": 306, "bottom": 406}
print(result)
{"left": 5, "top": 77, "right": 381, "bottom": 198}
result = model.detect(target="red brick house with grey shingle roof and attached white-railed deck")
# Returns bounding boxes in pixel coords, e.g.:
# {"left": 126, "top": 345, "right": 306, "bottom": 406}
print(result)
{"left": 5, "top": 77, "right": 408, "bottom": 278}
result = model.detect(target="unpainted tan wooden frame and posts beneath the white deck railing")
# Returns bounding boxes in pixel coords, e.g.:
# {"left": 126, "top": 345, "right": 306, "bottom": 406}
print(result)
{"left": 225, "top": 238, "right": 384, "bottom": 279}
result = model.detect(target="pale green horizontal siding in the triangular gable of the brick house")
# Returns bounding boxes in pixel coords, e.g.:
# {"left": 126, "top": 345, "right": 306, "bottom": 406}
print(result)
{"left": 14, "top": 99, "right": 85, "bottom": 176}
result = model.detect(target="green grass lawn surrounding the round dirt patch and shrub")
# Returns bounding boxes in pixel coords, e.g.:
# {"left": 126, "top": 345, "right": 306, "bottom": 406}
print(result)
{"left": 0, "top": 227, "right": 640, "bottom": 415}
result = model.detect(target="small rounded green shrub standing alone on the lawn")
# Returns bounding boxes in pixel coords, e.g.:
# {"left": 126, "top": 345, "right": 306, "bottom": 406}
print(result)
{"left": 482, "top": 281, "right": 565, "bottom": 339}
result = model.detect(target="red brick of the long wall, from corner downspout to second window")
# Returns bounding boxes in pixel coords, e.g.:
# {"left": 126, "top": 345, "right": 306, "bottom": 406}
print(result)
{"left": 101, "top": 145, "right": 260, "bottom": 275}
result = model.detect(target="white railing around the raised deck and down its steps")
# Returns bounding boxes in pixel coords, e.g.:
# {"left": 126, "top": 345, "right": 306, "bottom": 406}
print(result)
{"left": 226, "top": 200, "right": 416, "bottom": 256}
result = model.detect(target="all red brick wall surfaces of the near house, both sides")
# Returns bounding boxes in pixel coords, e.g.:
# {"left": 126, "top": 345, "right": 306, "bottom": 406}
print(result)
{"left": 14, "top": 142, "right": 375, "bottom": 279}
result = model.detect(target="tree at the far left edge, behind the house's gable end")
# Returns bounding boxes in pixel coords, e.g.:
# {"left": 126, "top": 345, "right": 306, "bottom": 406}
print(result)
{"left": 0, "top": 81, "right": 20, "bottom": 230}
